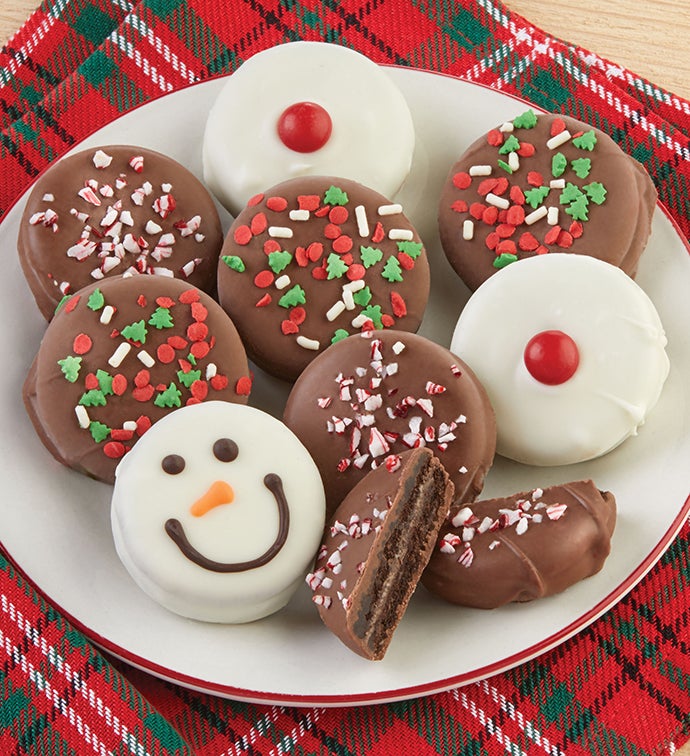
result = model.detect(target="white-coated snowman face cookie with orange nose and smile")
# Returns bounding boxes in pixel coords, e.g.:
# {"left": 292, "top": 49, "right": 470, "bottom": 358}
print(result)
{"left": 111, "top": 402, "right": 325, "bottom": 622}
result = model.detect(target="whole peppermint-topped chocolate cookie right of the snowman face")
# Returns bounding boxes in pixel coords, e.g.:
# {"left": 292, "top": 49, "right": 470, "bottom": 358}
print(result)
{"left": 284, "top": 330, "right": 496, "bottom": 513}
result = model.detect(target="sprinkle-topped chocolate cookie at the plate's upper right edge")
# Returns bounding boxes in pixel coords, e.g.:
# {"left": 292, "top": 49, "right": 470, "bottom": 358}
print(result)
{"left": 438, "top": 110, "right": 657, "bottom": 290}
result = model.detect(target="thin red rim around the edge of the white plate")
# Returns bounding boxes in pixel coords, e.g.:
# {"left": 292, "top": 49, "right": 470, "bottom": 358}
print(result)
{"left": 0, "top": 66, "right": 690, "bottom": 707}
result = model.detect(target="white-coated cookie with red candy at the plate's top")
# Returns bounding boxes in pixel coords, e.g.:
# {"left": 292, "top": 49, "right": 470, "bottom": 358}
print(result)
{"left": 203, "top": 42, "right": 415, "bottom": 215}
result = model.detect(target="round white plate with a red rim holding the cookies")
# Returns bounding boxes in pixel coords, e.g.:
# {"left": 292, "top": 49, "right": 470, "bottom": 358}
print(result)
{"left": 0, "top": 69, "right": 690, "bottom": 705}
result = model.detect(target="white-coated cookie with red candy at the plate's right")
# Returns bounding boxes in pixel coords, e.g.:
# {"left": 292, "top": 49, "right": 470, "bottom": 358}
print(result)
{"left": 451, "top": 253, "right": 669, "bottom": 465}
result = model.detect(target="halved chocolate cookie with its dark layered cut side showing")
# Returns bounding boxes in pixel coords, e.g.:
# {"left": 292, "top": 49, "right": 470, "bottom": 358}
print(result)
{"left": 307, "top": 447, "right": 453, "bottom": 660}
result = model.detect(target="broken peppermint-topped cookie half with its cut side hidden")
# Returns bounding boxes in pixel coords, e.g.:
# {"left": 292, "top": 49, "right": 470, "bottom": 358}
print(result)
{"left": 422, "top": 480, "right": 616, "bottom": 609}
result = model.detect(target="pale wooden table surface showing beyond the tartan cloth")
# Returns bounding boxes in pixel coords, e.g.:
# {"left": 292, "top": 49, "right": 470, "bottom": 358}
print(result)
{"left": 0, "top": 0, "right": 690, "bottom": 756}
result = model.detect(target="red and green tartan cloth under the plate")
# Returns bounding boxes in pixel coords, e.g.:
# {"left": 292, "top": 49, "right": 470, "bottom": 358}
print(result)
{"left": 0, "top": 0, "right": 690, "bottom": 756}
